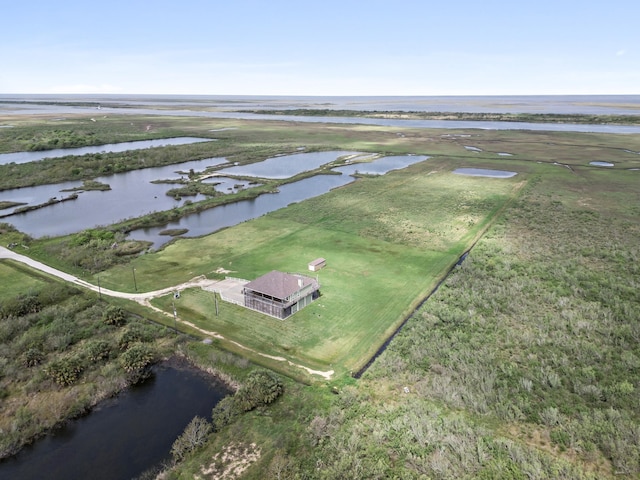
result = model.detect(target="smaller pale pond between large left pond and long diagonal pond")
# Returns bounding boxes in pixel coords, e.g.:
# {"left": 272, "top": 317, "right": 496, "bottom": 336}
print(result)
{"left": 220, "top": 150, "right": 358, "bottom": 178}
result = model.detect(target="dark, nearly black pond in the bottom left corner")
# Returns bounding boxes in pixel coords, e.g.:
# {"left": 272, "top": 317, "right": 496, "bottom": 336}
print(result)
{"left": 0, "top": 361, "right": 230, "bottom": 480}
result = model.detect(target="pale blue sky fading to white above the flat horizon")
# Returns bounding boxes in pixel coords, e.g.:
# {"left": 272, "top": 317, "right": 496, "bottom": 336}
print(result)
{"left": 0, "top": 0, "right": 640, "bottom": 96}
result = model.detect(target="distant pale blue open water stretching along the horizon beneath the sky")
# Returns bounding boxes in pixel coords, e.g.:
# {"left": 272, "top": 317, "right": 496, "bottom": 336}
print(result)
{"left": 0, "top": 94, "right": 640, "bottom": 115}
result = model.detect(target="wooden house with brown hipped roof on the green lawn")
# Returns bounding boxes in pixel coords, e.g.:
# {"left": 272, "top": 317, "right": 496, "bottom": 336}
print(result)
{"left": 243, "top": 270, "right": 320, "bottom": 318}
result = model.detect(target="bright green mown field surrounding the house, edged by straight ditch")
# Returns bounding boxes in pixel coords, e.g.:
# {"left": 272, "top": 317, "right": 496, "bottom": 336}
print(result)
{"left": 101, "top": 160, "right": 523, "bottom": 373}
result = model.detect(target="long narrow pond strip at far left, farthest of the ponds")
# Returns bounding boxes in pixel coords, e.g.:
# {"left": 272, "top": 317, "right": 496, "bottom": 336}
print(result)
{"left": 0, "top": 137, "right": 215, "bottom": 165}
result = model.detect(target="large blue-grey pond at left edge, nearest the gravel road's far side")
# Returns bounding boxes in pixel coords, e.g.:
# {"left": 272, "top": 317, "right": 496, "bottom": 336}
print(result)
{"left": 0, "top": 158, "right": 226, "bottom": 238}
